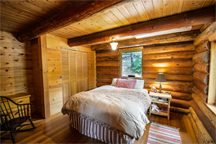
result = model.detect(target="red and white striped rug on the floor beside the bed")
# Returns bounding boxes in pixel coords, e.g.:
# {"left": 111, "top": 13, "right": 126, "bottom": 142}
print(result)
{"left": 147, "top": 122, "right": 182, "bottom": 144}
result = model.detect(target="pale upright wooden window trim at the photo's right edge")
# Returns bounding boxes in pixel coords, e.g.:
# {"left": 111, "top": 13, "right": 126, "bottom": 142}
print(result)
{"left": 208, "top": 41, "right": 216, "bottom": 104}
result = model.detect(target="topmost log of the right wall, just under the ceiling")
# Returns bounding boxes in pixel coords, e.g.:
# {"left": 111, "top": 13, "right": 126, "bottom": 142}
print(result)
{"left": 194, "top": 22, "right": 216, "bottom": 46}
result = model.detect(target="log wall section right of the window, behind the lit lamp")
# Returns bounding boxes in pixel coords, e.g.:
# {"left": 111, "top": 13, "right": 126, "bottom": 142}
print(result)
{"left": 143, "top": 42, "right": 195, "bottom": 113}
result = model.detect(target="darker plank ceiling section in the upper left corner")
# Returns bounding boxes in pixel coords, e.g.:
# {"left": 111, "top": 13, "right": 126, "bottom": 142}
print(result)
{"left": 0, "top": 0, "right": 72, "bottom": 33}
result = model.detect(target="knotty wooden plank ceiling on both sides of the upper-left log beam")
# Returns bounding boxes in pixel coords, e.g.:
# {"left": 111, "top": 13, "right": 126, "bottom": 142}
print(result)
{"left": 0, "top": 0, "right": 216, "bottom": 38}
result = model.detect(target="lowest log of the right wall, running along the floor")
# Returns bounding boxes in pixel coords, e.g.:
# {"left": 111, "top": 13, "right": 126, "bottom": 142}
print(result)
{"left": 189, "top": 107, "right": 214, "bottom": 143}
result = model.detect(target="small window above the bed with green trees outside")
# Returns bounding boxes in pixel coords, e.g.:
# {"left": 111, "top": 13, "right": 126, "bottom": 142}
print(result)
{"left": 121, "top": 51, "right": 142, "bottom": 77}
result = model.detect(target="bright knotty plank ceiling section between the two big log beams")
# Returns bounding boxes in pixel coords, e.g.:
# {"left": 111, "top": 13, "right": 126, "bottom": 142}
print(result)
{"left": 51, "top": 0, "right": 216, "bottom": 38}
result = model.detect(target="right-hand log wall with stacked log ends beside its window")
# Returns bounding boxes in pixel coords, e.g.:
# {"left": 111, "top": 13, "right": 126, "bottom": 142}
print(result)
{"left": 188, "top": 23, "right": 216, "bottom": 143}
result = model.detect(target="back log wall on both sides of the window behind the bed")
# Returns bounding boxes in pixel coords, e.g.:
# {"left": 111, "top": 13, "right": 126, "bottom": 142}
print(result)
{"left": 96, "top": 42, "right": 196, "bottom": 113}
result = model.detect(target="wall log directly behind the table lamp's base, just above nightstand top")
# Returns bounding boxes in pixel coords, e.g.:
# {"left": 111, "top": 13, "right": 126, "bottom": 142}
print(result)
{"left": 144, "top": 83, "right": 193, "bottom": 93}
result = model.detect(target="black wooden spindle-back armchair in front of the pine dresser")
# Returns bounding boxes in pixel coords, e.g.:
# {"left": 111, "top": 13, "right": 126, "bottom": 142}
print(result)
{"left": 0, "top": 96, "right": 35, "bottom": 144}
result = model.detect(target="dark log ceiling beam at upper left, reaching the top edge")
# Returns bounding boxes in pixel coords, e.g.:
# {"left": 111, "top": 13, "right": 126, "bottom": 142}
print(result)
{"left": 17, "top": 0, "right": 128, "bottom": 42}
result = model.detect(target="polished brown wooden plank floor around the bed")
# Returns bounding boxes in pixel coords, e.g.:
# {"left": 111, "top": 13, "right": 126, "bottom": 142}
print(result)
{"left": 0, "top": 113, "right": 198, "bottom": 144}
